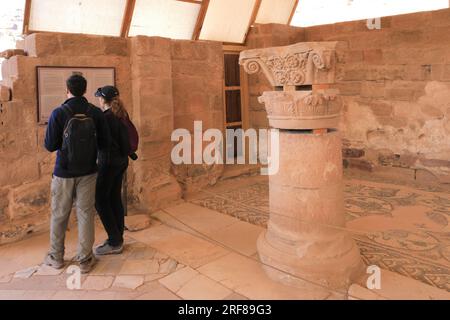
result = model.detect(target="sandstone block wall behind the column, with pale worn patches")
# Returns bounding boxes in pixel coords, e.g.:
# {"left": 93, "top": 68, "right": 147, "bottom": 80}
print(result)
{"left": 250, "top": 9, "right": 450, "bottom": 182}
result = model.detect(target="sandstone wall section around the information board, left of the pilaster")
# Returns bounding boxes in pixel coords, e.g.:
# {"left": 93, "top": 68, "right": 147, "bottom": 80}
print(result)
{"left": 0, "top": 34, "right": 131, "bottom": 243}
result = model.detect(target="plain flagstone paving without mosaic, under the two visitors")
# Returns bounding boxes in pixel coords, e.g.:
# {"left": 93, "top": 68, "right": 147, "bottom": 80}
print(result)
{"left": 0, "top": 208, "right": 346, "bottom": 300}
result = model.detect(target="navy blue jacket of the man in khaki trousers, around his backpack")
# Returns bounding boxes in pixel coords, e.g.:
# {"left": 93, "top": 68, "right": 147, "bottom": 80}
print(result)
{"left": 45, "top": 97, "right": 111, "bottom": 178}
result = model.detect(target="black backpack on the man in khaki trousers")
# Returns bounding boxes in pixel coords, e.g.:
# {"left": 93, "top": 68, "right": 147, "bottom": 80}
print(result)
{"left": 61, "top": 104, "right": 97, "bottom": 175}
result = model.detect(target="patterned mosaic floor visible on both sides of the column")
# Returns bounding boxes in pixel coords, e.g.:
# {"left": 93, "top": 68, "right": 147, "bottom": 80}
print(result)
{"left": 189, "top": 177, "right": 450, "bottom": 291}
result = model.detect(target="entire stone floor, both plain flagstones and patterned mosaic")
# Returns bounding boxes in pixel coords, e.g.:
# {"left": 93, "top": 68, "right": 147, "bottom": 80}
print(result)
{"left": 0, "top": 172, "right": 450, "bottom": 300}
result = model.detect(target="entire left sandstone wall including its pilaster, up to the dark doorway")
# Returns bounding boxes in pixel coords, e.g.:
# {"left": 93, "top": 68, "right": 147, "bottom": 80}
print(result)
{"left": 0, "top": 34, "right": 223, "bottom": 244}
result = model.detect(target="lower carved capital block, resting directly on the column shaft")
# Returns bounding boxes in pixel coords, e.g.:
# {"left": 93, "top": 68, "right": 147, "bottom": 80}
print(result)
{"left": 258, "top": 89, "right": 342, "bottom": 130}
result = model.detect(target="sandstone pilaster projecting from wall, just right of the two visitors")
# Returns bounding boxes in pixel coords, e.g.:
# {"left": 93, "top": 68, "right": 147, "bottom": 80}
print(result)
{"left": 130, "top": 37, "right": 181, "bottom": 211}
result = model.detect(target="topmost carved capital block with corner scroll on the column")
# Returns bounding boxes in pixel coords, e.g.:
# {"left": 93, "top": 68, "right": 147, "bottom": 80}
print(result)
{"left": 239, "top": 42, "right": 339, "bottom": 87}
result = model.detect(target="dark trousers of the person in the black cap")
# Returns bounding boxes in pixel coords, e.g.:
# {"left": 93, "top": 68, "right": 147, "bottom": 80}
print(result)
{"left": 95, "top": 162, "right": 128, "bottom": 246}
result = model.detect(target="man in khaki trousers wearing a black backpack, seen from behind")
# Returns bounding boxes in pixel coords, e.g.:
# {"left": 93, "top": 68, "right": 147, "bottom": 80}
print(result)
{"left": 44, "top": 75, "right": 110, "bottom": 273}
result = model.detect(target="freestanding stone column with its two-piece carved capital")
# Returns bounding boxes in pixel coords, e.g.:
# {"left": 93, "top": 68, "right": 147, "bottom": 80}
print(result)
{"left": 240, "top": 42, "right": 363, "bottom": 288}
